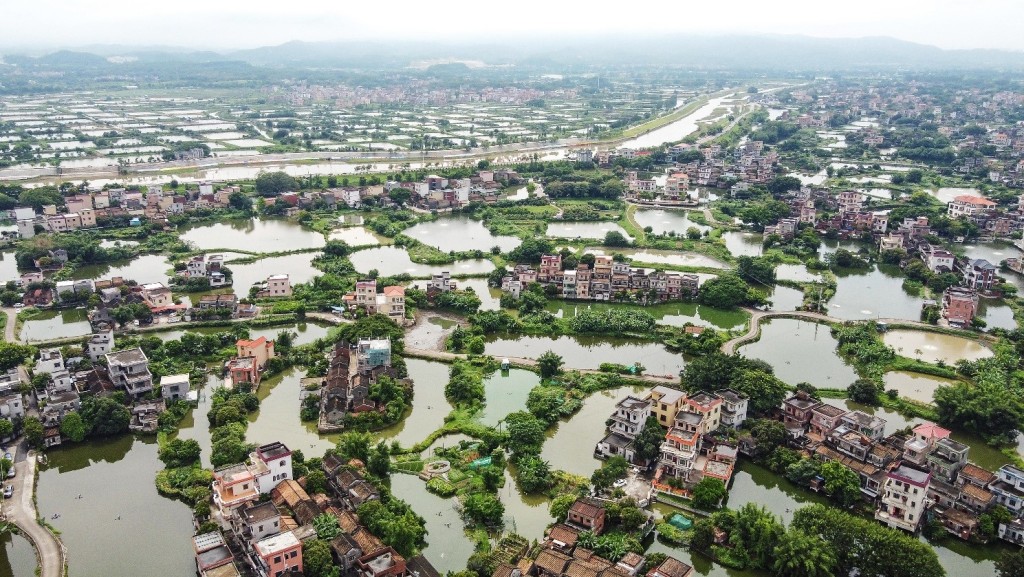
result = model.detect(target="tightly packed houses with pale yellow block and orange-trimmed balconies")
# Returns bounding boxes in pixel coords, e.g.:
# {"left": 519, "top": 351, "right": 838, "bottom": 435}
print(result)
{"left": 594, "top": 386, "right": 748, "bottom": 495}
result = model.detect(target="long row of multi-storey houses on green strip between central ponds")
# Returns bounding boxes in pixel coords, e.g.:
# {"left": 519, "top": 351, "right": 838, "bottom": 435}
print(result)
{"left": 502, "top": 254, "right": 700, "bottom": 302}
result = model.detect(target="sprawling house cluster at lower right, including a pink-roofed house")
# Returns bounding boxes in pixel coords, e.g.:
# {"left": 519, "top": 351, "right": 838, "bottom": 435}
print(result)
{"left": 778, "top": 391, "right": 1024, "bottom": 544}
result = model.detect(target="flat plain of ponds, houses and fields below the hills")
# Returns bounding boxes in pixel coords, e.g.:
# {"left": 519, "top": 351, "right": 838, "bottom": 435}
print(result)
{"left": 0, "top": 50, "right": 1024, "bottom": 577}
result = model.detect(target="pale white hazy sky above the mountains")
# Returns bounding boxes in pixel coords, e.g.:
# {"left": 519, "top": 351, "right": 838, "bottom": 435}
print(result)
{"left": 0, "top": 0, "right": 1024, "bottom": 51}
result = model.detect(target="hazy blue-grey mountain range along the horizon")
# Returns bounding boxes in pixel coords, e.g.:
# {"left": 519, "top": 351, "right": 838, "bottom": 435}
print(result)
{"left": 3, "top": 35, "right": 1024, "bottom": 71}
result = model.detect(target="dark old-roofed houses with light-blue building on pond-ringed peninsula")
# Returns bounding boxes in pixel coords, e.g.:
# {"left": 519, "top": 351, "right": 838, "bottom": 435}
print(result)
{"left": 318, "top": 338, "right": 395, "bottom": 432}
